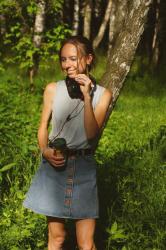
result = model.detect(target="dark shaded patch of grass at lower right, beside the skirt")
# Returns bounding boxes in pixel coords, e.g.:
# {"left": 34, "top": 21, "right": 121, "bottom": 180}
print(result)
{"left": 96, "top": 126, "right": 166, "bottom": 250}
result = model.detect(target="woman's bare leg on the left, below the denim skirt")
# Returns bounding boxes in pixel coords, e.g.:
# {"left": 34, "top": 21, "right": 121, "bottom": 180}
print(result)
{"left": 47, "top": 217, "right": 66, "bottom": 250}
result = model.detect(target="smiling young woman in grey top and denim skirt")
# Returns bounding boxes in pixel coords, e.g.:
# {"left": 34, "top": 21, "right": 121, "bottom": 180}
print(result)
{"left": 24, "top": 36, "right": 111, "bottom": 250}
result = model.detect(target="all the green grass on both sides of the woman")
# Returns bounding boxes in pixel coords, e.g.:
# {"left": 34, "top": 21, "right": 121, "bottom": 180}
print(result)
{"left": 0, "top": 59, "right": 166, "bottom": 250}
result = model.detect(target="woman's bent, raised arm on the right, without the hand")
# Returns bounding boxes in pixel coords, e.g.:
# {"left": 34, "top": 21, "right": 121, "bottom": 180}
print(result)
{"left": 84, "top": 89, "right": 112, "bottom": 140}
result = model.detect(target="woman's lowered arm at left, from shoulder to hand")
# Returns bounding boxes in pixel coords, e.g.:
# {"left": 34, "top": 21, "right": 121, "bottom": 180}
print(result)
{"left": 38, "top": 83, "right": 63, "bottom": 167}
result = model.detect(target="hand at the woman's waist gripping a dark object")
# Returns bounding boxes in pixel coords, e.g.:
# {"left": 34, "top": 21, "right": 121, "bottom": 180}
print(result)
{"left": 42, "top": 147, "right": 65, "bottom": 168}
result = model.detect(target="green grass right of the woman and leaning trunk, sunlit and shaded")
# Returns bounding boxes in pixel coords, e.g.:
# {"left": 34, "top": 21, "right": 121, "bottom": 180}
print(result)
{"left": 96, "top": 68, "right": 166, "bottom": 250}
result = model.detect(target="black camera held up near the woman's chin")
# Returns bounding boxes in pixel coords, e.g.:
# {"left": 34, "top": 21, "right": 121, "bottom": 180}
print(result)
{"left": 66, "top": 76, "right": 96, "bottom": 100}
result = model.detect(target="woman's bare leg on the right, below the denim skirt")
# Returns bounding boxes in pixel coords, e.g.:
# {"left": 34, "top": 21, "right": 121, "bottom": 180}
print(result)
{"left": 76, "top": 219, "right": 96, "bottom": 250}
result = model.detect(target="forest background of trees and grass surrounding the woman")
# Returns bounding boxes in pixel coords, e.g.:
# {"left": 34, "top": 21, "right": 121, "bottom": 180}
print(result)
{"left": 0, "top": 0, "right": 166, "bottom": 250}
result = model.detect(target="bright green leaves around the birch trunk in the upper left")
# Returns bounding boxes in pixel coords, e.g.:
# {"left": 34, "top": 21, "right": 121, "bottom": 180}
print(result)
{"left": 0, "top": 0, "right": 70, "bottom": 72}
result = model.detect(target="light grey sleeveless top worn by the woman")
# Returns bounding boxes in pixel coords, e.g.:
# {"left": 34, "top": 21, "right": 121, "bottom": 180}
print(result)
{"left": 49, "top": 80, "right": 105, "bottom": 149}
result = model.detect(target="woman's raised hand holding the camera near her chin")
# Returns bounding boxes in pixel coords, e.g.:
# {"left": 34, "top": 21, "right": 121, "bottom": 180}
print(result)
{"left": 75, "top": 74, "right": 92, "bottom": 97}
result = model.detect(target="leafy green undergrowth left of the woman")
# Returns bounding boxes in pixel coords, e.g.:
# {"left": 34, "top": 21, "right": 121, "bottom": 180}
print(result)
{"left": 0, "top": 72, "right": 46, "bottom": 250}
